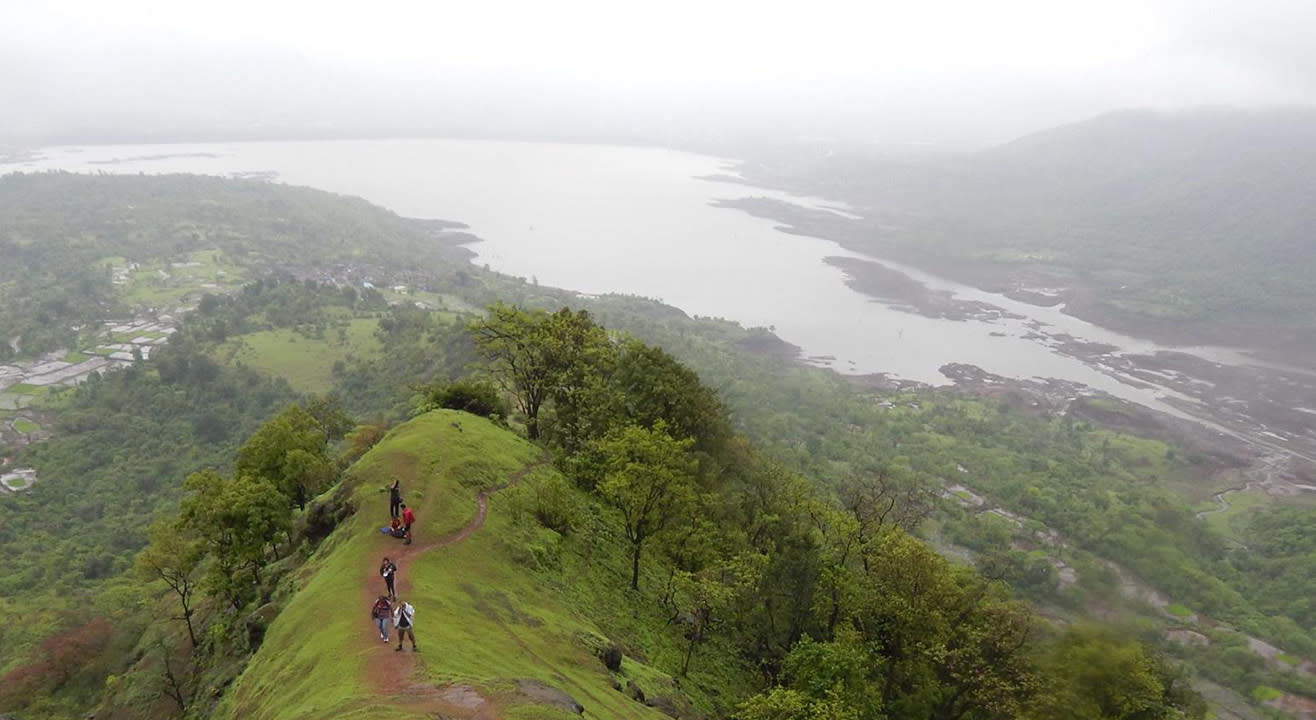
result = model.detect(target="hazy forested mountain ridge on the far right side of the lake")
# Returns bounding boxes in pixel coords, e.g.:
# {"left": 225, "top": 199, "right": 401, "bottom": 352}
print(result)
{"left": 746, "top": 108, "right": 1316, "bottom": 351}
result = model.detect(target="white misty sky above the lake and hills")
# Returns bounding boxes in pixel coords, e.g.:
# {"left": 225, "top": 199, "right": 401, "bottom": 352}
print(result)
{"left": 0, "top": 0, "right": 1316, "bottom": 147}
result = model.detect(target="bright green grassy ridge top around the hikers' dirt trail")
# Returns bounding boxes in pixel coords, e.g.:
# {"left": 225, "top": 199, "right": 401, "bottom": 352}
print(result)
{"left": 215, "top": 411, "right": 679, "bottom": 720}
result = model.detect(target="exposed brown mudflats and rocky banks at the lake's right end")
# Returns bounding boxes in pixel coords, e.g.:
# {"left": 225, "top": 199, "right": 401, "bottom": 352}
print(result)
{"left": 713, "top": 192, "right": 1316, "bottom": 496}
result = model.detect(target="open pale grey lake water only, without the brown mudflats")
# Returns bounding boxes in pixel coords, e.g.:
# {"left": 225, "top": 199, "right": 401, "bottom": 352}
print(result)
{"left": 18, "top": 140, "right": 1246, "bottom": 415}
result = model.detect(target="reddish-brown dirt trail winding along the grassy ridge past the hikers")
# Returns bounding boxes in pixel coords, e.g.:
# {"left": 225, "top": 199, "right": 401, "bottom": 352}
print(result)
{"left": 361, "top": 458, "right": 549, "bottom": 720}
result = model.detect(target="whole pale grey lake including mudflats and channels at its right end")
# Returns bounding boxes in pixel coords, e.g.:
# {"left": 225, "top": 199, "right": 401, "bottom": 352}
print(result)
{"left": 17, "top": 141, "right": 1316, "bottom": 484}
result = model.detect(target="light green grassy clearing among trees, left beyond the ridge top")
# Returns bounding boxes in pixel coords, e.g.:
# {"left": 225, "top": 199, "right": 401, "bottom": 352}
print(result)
{"left": 217, "top": 319, "right": 382, "bottom": 392}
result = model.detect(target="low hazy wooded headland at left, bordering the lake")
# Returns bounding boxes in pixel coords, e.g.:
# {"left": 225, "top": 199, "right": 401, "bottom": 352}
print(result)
{"left": 0, "top": 172, "right": 463, "bottom": 361}
